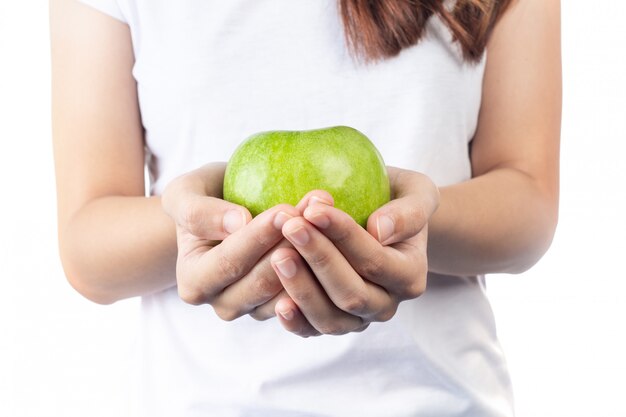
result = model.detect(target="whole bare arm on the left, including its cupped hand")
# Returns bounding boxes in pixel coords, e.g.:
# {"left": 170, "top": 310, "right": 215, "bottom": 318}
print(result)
{"left": 50, "top": 0, "right": 288, "bottom": 308}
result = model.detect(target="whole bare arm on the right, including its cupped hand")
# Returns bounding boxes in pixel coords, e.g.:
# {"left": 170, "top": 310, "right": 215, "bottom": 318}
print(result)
{"left": 272, "top": 0, "right": 561, "bottom": 336}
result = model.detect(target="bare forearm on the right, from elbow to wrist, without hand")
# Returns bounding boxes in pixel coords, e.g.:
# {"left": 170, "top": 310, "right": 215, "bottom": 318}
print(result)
{"left": 428, "top": 168, "right": 558, "bottom": 275}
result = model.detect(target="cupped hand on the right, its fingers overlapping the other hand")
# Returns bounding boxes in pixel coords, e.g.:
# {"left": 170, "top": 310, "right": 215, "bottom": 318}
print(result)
{"left": 271, "top": 167, "right": 439, "bottom": 337}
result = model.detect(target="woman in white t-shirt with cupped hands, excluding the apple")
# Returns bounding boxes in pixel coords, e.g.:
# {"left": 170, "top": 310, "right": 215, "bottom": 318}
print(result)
{"left": 51, "top": 0, "right": 561, "bottom": 417}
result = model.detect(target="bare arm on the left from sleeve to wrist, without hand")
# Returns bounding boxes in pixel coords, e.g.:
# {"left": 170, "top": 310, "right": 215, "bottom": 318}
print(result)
{"left": 50, "top": 0, "right": 176, "bottom": 303}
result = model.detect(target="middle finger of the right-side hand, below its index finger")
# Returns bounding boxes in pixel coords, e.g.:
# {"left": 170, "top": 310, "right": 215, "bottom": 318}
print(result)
{"left": 283, "top": 221, "right": 394, "bottom": 320}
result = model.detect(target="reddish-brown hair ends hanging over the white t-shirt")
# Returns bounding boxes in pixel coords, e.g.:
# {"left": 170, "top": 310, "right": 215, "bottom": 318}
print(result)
{"left": 339, "top": 0, "right": 511, "bottom": 62}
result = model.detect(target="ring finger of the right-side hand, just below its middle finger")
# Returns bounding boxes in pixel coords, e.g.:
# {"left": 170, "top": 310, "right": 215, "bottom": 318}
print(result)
{"left": 271, "top": 248, "right": 363, "bottom": 335}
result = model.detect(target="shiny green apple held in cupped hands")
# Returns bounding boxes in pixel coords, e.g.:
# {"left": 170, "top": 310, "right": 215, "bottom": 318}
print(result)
{"left": 224, "top": 126, "right": 390, "bottom": 227}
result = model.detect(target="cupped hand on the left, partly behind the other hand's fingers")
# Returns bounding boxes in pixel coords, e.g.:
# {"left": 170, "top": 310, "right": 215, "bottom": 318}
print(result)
{"left": 161, "top": 163, "right": 300, "bottom": 320}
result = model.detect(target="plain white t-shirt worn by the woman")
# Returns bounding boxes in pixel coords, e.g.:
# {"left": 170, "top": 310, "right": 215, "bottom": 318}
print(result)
{"left": 77, "top": 0, "right": 513, "bottom": 417}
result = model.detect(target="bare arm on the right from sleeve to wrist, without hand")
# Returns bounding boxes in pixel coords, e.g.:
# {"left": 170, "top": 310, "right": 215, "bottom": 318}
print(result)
{"left": 428, "top": 0, "right": 561, "bottom": 275}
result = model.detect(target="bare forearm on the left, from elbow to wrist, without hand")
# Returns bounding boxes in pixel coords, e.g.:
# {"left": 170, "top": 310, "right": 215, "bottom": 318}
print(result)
{"left": 59, "top": 196, "right": 177, "bottom": 304}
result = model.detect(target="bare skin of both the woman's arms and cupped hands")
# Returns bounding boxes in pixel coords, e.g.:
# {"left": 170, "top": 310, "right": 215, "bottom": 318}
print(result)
{"left": 50, "top": 0, "right": 561, "bottom": 336}
